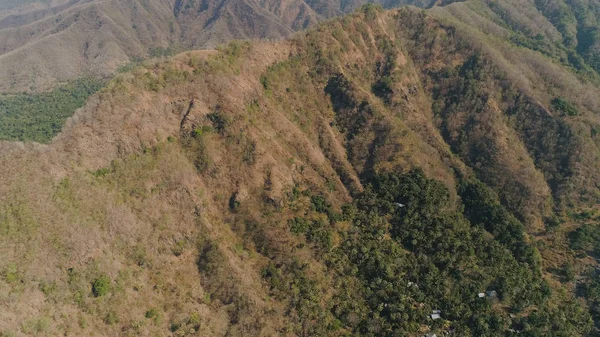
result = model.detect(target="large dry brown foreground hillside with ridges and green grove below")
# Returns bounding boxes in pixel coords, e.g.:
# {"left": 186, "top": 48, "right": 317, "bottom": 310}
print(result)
{"left": 0, "top": 1, "right": 600, "bottom": 337}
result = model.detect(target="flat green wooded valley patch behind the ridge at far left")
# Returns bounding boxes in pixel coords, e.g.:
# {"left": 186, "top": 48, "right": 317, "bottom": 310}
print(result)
{"left": 0, "top": 78, "right": 104, "bottom": 143}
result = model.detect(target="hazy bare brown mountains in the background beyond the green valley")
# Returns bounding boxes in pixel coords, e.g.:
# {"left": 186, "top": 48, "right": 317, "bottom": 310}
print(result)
{"left": 0, "top": 0, "right": 454, "bottom": 93}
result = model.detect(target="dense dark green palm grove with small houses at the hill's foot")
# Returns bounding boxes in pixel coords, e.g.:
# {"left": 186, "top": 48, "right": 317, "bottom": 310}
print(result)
{"left": 255, "top": 170, "right": 599, "bottom": 337}
